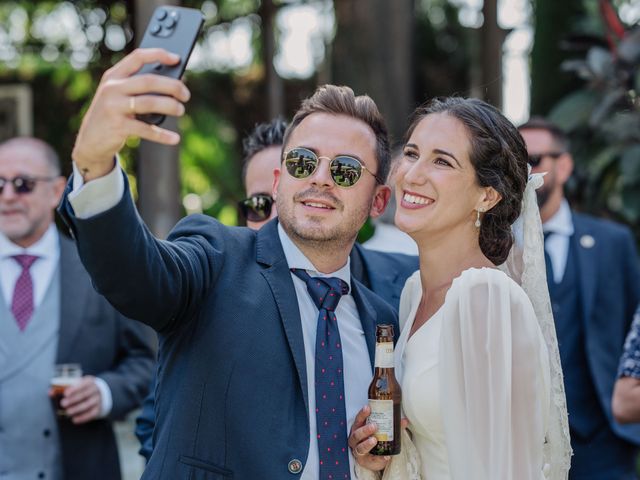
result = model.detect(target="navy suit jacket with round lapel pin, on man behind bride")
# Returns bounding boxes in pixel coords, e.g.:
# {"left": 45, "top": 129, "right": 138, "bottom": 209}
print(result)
{"left": 560, "top": 213, "right": 640, "bottom": 445}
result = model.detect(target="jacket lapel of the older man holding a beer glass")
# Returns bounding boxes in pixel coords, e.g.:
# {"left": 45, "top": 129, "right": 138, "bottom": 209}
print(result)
{"left": 57, "top": 235, "right": 91, "bottom": 363}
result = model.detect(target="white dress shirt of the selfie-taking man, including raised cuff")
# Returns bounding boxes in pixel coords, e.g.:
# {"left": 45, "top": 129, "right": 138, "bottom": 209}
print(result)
{"left": 69, "top": 161, "right": 373, "bottom": 480}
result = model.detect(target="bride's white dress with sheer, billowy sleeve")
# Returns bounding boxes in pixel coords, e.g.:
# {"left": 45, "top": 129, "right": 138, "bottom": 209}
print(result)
{"left": 358, "top": 268, "right": 551, "bottom": 480}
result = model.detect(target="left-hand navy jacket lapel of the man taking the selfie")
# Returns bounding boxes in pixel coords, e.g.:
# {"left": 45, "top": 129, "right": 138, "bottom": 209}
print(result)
{"left": 256, "top": 220, "right": 309, "bottom": 408}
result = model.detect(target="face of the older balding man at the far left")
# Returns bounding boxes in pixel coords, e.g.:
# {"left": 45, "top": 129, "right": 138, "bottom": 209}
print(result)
{"left": 0, "top": 143, "right": 64, "bottom": 247}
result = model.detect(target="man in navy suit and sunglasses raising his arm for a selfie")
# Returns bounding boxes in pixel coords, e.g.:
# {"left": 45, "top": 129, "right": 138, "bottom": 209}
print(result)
{"left": 55, "top": 49, "right": 404, "bottom": 480}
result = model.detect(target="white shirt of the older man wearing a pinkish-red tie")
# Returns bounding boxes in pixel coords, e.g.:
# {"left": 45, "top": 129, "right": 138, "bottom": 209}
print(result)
{"left": 0, "top": 223, "right": 113, "bottom": 417}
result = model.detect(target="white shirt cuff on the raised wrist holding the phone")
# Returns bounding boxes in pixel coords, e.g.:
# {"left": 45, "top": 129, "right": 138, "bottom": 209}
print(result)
{"left": 68, "top": 156, "right": 124, "bottom": 219}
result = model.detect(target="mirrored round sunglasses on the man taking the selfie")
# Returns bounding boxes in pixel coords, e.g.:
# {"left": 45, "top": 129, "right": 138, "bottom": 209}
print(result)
{"left": 284, "top": 147, "right": 384, "bottom": 188}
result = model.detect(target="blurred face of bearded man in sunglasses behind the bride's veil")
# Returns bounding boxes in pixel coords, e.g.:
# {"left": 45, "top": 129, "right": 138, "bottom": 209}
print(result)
{"left": 520, "top": 128, "right": 573, "bottom": 209}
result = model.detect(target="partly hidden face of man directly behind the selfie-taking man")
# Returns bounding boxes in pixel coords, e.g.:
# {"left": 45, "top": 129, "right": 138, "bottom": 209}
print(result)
{"left": 244, "top": 146, "right": 282, "bottom": 230}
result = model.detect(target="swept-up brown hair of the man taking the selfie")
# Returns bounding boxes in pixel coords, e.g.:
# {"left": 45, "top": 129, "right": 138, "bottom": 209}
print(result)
{"left": 284, "top": 85, "right": 391, "bottom": 181}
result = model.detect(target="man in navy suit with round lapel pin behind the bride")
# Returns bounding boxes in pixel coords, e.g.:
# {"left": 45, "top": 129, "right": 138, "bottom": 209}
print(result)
{"left": 519, "top": 118, "right": 640, "bottom": 480}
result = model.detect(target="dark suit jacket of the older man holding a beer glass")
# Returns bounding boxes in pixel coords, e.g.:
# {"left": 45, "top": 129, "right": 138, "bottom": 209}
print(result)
{"left": 57, "top": 236, "right": 155, "bottom": 480}
